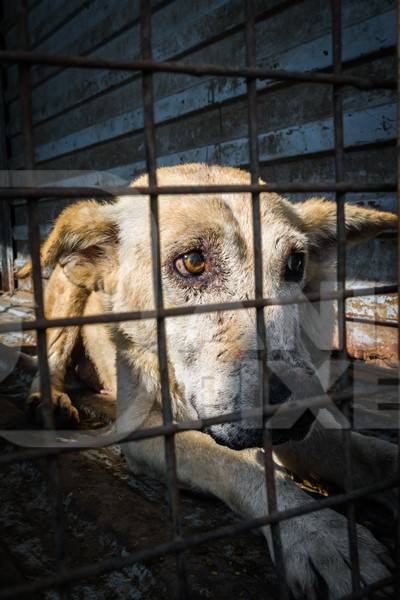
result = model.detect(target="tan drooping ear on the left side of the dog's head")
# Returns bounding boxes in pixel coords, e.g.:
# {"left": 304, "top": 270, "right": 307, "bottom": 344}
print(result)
{"left": 17, "top": 200, "right": 118, "bottom": 290}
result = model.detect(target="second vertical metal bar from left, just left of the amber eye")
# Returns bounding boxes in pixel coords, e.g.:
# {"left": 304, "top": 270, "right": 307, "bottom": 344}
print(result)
{"left": 140, "top": 0, "right": 188, "bottom": 598}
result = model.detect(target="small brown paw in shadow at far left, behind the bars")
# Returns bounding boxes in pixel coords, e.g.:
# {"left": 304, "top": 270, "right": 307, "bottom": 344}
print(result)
{"left": 25, "top": 389, "right": 79, "bottom": 429}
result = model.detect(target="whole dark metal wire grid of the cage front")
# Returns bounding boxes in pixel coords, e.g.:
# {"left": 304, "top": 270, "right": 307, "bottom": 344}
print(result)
{"left": 0, "top": 0, "right": 400, "bottom": 599}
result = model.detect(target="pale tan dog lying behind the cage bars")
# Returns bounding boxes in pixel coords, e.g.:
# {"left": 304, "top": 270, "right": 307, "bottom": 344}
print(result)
{"left": 20, "top": 164, "right": 397, "bottom": 599}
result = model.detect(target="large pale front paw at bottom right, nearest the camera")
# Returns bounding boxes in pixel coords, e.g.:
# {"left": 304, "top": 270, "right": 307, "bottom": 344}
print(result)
{"left": 281, "top": 510, "right": 391, "bottom": 600}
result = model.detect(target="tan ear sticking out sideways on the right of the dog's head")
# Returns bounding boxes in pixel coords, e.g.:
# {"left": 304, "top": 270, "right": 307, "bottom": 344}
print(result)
{"left": 297, "top": 199, "right": 397, "bottom": 253}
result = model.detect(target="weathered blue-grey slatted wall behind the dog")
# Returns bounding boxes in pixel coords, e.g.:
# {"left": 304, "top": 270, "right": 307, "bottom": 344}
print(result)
{"left": 0, "top": 0, "right": 396, "bottom": 364}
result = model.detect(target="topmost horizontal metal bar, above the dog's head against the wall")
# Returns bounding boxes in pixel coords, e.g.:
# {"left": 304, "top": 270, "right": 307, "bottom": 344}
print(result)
{"left": 0, "top": 50, "right": 397, "bottom": 89}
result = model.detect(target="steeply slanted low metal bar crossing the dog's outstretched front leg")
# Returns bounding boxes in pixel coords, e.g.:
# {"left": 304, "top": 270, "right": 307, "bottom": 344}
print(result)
{"left": 0, "top": 478, "right": 400, "bottom": 600}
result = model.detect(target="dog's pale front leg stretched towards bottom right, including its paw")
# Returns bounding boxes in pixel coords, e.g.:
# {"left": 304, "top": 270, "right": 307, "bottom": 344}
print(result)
{"left": 125, "top": 413, "right": 388, "bottom": 599}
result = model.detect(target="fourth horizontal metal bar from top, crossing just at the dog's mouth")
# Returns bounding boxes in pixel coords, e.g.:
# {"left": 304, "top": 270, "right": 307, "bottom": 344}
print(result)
{"left": 0, "top": 392, "right": 390, "bottom": 467}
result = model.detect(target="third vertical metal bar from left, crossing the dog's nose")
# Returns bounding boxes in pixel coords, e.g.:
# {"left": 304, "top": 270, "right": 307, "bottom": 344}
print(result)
{"left": 245, "top": 0, "right": 289, "bottom": 600}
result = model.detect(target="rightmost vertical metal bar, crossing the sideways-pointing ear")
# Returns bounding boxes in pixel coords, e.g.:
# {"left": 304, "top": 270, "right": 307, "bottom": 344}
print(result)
{"left": 332, "top": 0, "right": 360, "bottom": 591}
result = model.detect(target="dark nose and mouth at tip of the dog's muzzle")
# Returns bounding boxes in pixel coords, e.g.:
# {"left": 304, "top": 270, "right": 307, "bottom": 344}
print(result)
{"left": 189, "top": 353, "right": 324, "bottom": 450}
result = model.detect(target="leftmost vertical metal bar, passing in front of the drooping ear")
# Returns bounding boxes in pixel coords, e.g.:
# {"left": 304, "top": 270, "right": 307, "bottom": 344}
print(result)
{"left": 19, "top": 0, "right": 66, "bottom": 596}
